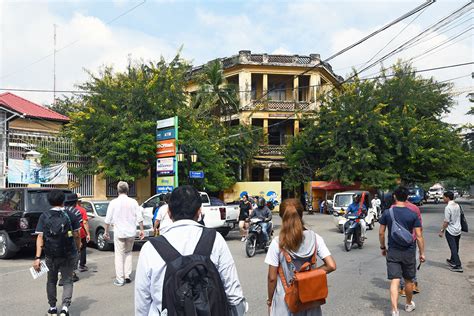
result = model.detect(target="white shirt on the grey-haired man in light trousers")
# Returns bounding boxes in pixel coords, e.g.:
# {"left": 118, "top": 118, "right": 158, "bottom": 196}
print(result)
{"left": 105, "top": 194, "right": 143, "bottom": 238}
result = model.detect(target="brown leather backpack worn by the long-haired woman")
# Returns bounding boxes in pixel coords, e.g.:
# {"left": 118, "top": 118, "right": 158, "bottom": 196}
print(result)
{"left": 278, "top": 244, "right": 328, "bottom": 313}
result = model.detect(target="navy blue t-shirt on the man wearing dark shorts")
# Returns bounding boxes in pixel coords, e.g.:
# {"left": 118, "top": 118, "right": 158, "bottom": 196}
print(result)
{"left": 379, "top": 206, "right": 421, "bottom": 250}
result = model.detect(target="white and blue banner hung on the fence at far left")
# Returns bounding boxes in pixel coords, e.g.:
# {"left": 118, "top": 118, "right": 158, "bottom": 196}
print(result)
{"left": 8, "top": 159, "right": 68, "bottom": 184}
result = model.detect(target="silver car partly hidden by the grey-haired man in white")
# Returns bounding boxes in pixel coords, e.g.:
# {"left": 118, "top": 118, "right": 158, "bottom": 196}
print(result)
{"left": 82, "top": 201, "right": 153, "bottom": 251}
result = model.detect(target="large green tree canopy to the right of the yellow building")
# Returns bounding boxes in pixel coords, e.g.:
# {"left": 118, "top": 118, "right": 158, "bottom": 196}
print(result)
{"left": 285, "top": 62, "right": 468, "bottom": 188}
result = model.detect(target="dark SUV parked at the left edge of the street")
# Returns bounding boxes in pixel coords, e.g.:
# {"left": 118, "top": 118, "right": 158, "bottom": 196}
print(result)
{"left": 0, "top": 188, "right": 72, "bottom": 259}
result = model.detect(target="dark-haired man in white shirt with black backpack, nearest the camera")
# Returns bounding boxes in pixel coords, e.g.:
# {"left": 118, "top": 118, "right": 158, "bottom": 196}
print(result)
{"left": 135, "top": 185, "right": 247, "bottom": 316}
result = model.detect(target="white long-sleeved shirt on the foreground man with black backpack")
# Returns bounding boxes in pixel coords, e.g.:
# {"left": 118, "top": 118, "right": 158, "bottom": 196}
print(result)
{"left": 135, "top": 220, "right": 244, "bottom": 316}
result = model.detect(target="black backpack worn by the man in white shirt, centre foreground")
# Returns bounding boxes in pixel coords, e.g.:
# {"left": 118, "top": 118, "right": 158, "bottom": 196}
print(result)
{"left": 150, "top": 228, "right": 231, "bottom": 316}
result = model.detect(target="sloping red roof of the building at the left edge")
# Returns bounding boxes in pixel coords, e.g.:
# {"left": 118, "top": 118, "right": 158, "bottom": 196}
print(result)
{"left": 0, "top": 92, "right": 69, "bottom": 122}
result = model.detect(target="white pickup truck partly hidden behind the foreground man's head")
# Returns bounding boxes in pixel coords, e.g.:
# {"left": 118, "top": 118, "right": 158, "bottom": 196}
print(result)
{"left": 142, "top": 192, "right": 240, "bottom": 236}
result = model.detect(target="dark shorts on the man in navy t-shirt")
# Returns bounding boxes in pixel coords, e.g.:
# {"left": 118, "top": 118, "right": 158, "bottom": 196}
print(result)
{"left": 387, "top": 248, "right": 416, "bottom": 280}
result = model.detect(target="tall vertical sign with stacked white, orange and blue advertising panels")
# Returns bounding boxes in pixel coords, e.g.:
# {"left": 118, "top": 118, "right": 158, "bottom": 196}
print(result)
{"left": 156, "top": 116, "right": 178, "bottom": 193}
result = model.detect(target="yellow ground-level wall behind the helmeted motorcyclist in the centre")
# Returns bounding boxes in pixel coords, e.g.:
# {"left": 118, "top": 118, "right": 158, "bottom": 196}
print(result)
{"left": 224, "top": 181, "right": 281, "bottom": 212}
